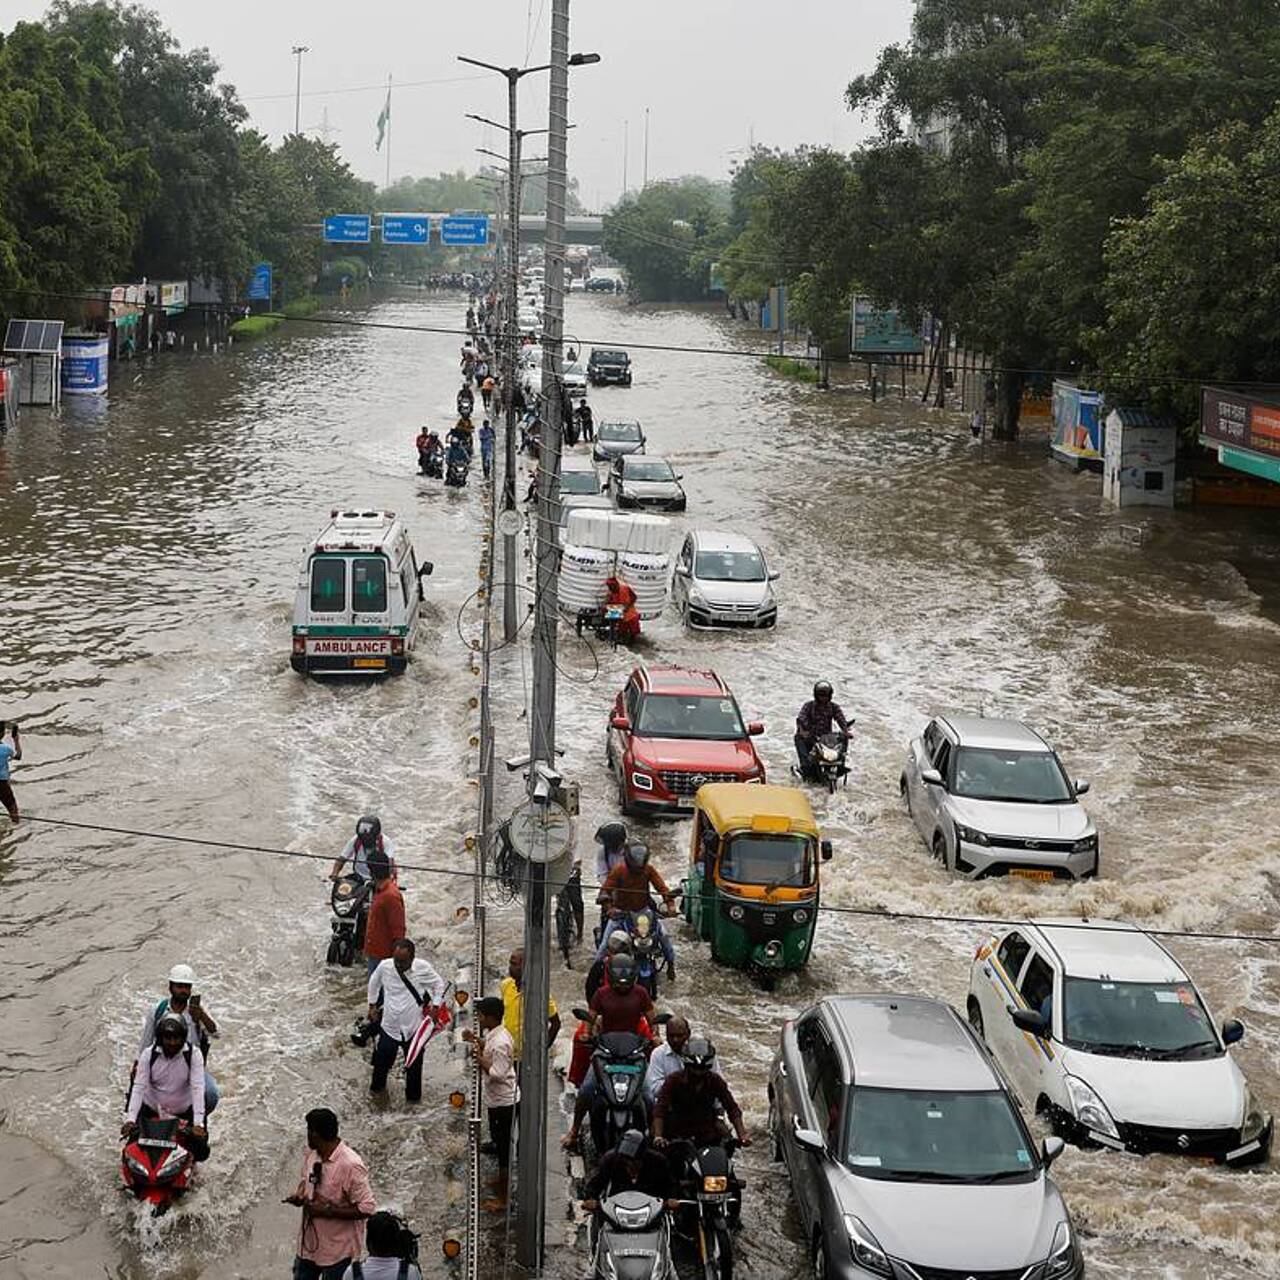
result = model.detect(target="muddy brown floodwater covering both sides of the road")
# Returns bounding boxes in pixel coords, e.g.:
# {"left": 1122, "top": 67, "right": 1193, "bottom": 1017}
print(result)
{"left": 0, "top": 296, "right": 1280, "bottom": 1277}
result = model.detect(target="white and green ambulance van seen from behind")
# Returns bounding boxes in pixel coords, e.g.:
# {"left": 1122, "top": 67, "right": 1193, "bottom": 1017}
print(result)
{"left": 289, "top": 507, "right": 433, "bottom": 676}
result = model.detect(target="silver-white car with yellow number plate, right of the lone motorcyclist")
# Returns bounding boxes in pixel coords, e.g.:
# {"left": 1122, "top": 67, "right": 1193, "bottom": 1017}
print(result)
{"left": 899, "top": 716, "right": 1100, "bottom": 881}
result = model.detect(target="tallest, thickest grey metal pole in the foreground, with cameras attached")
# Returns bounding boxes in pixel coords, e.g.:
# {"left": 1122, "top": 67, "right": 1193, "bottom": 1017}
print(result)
{"left": 516, "top": 10, "right": 600, "bottom": 1271}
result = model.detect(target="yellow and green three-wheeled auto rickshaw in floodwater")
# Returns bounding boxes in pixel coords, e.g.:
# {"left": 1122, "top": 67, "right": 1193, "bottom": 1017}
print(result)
{"left": 685, "top": 782, "right": 831, "bottom": 988}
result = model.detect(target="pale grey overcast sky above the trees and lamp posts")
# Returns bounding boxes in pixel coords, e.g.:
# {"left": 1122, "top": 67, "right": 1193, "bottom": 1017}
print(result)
{"left": 0, "top": 0, "right": 913, "bottom": 209}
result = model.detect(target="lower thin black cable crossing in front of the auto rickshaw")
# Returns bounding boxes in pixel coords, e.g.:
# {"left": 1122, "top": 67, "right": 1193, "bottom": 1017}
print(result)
{"left": 23, "top": 813, "right": 1280, "bottom": 946}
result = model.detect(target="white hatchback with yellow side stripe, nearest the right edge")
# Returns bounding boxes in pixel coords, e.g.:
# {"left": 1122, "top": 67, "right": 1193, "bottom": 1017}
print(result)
{"left": 968, "top": 919, "right": 1274, "bottom": 1165}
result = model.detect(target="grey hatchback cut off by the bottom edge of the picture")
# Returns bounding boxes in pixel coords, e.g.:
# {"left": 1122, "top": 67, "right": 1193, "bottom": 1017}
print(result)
{"left": 769, "top": 996, "right": 1084, "bottom": 1280}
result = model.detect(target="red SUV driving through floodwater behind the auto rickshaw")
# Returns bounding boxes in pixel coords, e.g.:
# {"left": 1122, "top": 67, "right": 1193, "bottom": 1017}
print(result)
{"left": 605, "top": 667, "right": 764, "bottom": 814}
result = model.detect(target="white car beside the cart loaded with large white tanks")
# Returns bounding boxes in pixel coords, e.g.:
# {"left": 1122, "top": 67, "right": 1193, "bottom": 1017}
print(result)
{"left": 672, "top": 529, "right": 778, "bottom": 631}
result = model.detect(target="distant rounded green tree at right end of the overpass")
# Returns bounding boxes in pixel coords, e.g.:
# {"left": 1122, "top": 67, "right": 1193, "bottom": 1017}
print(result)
{"left": 604, "top": 177, "right": 728, "bottom": 302}
